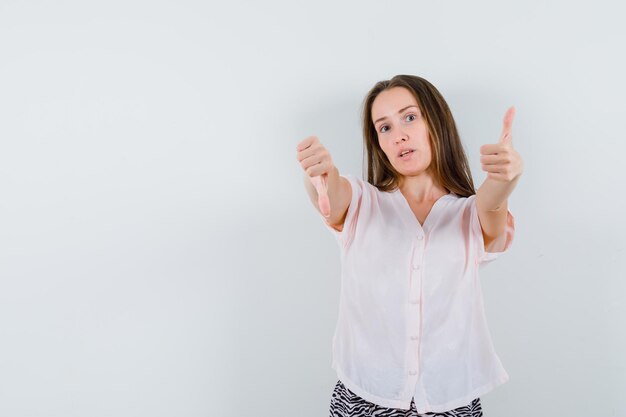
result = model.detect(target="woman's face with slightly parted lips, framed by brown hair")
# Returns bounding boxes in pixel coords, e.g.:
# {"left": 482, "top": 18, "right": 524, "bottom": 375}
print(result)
{"left": 372, "top": 87, "right": 431, "bottom": 176}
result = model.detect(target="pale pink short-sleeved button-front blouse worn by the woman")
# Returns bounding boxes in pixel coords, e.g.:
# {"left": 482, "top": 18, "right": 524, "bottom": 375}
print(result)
{"left": 320, "top": 175, "right": 515, "bottom": 413}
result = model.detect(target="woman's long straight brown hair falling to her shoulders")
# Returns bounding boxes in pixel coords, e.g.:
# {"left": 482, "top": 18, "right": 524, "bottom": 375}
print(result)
{"left": 362, "top": 74, "right": 476, "bottom": 197}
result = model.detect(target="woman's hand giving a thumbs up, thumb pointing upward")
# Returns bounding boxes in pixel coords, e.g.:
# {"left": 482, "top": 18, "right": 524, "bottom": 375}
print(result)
{"left": 480, "top": 107, "right": 524, "bottom": 182}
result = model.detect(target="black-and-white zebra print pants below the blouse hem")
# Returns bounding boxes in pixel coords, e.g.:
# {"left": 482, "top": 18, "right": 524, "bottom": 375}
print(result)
{"left": 330, "top": 380, "right": 483, "bottom": 417}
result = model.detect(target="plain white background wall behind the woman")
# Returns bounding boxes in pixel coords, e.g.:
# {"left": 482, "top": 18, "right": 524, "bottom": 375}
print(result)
{"left": 0, "top": 0, "right": 626, "bottom": 417}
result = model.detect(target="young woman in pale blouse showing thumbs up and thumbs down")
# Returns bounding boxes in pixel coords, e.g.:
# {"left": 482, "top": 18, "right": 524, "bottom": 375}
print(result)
{"left": 297, "top": 75, "right": 523, "bottom": 417}
